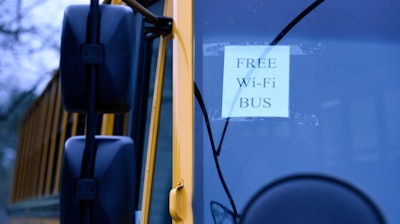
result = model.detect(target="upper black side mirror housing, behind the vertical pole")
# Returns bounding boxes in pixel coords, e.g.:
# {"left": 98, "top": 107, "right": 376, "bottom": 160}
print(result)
{"left": 60, "top": 5, "right": 143, "bottom": 113}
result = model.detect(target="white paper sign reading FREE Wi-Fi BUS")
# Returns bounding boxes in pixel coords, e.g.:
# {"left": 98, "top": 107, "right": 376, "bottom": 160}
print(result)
{"left": 222, "top": 45, "right": 290, "bottom": 117}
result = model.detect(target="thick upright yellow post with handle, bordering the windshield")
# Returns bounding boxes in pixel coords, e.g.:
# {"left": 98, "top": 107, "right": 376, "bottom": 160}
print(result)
{"left": 170, "top": 0, "right": 194, "bottom": 223}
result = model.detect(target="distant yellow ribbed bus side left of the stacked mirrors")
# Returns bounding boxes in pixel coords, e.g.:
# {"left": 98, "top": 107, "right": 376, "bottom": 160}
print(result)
{"left": 10, "top": 71, "right": 68, "bottom": 203}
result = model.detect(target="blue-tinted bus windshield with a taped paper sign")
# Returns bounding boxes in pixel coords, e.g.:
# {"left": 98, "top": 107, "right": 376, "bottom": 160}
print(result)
{"left": 194, "top": 0, "right": 400, "bottom": 223}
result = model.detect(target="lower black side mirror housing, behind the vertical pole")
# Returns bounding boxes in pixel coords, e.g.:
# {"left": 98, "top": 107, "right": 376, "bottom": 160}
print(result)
{"left": 60, "top": 136, "right": 136, "bottom": 223}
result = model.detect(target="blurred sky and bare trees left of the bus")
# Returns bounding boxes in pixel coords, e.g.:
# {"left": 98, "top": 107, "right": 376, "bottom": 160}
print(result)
{"left": 0, "top": 0, "right": 86, "bottom": 220}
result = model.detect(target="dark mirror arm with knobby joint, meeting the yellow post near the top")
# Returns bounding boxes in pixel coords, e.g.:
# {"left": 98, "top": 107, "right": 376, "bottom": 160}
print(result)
{"left": 122, "top": 0, "right": 172, "bottom": 36}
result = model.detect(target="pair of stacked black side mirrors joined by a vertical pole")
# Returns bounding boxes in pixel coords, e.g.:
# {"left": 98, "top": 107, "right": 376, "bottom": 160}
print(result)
{"left": 60, "top": 3, "right": 143, "bottom": 224}
